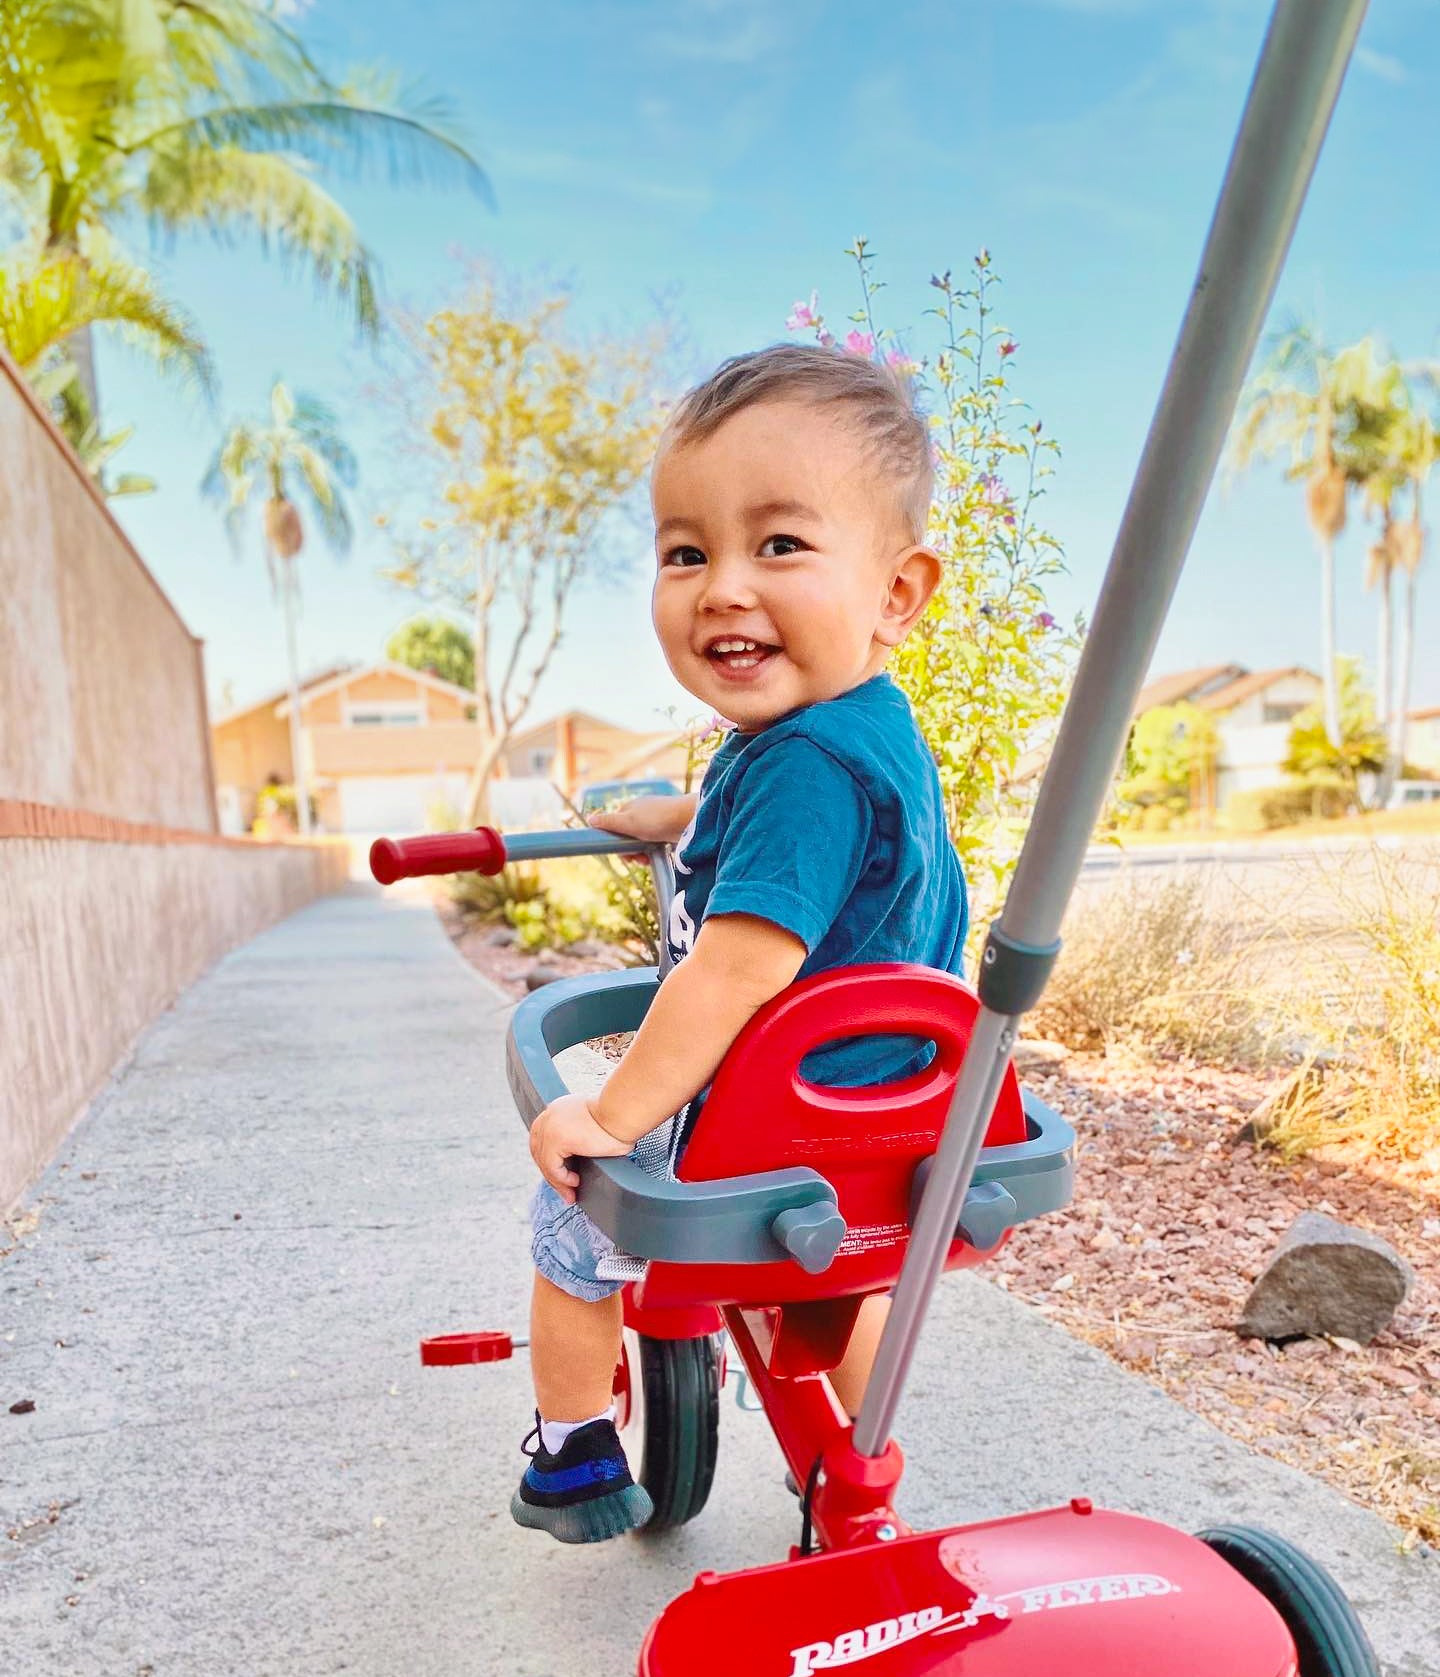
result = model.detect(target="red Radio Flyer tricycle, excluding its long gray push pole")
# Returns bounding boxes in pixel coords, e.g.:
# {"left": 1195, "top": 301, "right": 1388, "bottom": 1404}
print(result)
{"left": 370, "top": 811, "right": 1376, "bottom": 1677}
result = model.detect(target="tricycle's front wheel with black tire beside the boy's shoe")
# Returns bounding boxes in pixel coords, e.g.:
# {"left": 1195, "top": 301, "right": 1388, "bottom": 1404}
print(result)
{"left": 620, "top": 1328, "right": 719, "bottom": 1531}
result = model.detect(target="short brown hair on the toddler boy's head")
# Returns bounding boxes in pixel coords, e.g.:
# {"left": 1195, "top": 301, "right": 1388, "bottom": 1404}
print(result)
{"left": 662, "top": 344, "right": 935, "bottom": 542}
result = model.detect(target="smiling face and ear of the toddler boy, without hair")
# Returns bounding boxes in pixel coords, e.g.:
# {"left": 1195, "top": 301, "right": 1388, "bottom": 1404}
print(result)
{"left": 650, "top": 402, "right": 939, "bottom": 733}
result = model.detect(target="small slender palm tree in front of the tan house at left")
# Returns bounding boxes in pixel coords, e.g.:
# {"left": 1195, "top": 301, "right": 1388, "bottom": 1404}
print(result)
{"left": 201, "top": 381, "right": 355, "bottom": 833}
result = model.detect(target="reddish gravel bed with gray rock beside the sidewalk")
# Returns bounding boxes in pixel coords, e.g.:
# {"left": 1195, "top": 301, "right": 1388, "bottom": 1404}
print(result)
{"left": 438, "top": 899, "right": 1440, "bottom": 1548}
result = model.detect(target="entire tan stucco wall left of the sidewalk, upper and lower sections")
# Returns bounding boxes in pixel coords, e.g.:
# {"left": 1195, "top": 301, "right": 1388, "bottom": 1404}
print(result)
{"left": 0, "top": 354, "right": 349, "bottom": 1211}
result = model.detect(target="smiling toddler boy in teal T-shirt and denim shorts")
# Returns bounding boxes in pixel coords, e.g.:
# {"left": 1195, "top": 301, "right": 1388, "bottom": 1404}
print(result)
{"left": 511, "top": 345, "right": 966, "bottom": 1543}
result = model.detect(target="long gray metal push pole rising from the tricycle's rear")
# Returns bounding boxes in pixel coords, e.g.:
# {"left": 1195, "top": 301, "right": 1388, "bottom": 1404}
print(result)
{"left": 855, "top": 0, "right": 1366, "bottom": 1456}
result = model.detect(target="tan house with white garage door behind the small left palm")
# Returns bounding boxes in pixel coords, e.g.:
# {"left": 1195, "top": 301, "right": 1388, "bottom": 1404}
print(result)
{"left": 213, "top": 659, "right": 481, "bottom": 833}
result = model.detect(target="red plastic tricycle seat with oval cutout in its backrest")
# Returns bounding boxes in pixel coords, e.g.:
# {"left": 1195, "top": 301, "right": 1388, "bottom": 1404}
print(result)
{"left": 637, "top": 966, "right": 1026, "bottom": 1306}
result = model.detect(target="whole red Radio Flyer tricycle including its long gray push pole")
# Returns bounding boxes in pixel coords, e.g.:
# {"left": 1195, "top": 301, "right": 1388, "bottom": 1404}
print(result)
{"left": 372, "top": 0, "right": 1378, "bottom": 1677}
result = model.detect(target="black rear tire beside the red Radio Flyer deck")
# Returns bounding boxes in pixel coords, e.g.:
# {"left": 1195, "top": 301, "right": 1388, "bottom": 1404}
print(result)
{"left": 1197, "top": 1526, "right": 1380, "bottom": 1677}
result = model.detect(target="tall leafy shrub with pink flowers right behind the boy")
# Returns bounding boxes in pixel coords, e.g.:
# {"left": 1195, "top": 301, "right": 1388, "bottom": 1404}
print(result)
{"left": 786, "top": 238, "right": 1080, "bottom": 927}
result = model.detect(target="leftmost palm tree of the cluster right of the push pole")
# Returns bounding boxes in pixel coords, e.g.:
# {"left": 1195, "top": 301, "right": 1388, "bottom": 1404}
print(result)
{"left": 1230, "top": 322, "right": 1385, "bottom": 748}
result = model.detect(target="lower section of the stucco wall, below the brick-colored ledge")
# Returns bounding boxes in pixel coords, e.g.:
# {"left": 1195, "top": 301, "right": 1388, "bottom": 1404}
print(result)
{"left": 0, "top": 839, "right": 349, "bottom": 1211}
